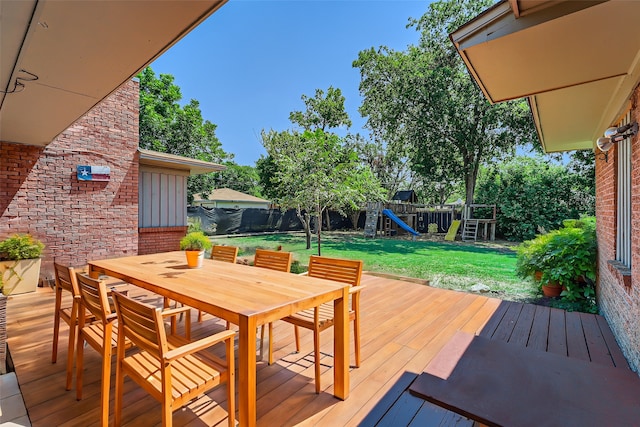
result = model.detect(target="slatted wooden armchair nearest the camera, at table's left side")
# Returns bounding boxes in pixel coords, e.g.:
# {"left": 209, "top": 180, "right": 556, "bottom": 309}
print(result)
{"left": 113, "top": 292, "right": 235, "bottom": 426}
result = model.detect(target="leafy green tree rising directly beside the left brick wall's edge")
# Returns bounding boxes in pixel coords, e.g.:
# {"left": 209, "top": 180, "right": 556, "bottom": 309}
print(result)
{"left": 138, "top": 67, "right": 233, "bottom": 202}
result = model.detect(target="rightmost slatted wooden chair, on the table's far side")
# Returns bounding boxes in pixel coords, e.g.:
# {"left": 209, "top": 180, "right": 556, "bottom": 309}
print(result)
{"left": 282, "top": 255, "right": 363, "bottom": 393}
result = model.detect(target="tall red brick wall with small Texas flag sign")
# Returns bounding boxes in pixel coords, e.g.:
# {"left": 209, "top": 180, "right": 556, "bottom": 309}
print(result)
{"left": 0, "top": 81, "right": 139, "bottom": 279}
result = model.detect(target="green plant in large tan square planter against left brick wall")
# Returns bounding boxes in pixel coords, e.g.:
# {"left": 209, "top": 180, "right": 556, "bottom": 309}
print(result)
{"left": 0, "top": 234, "right": 44, "bottom": 295}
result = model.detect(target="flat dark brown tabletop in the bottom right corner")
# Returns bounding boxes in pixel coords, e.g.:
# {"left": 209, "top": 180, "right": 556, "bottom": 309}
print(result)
{"left": 409, "top": 332, "right": 640, "bottom": 427}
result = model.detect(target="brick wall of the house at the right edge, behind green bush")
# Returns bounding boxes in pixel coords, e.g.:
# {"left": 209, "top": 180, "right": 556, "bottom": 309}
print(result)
{"left": 596, "top": 86, "right": 640, "bottom": 372}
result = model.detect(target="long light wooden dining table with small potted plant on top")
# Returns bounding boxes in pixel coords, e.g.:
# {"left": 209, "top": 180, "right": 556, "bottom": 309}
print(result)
{"left": 89, "top": 251, "right": 349, "bottom": 426}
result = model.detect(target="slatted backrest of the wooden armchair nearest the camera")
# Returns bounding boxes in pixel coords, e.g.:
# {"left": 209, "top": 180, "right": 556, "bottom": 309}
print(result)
{"left": 112, "top": 291, "right": 168, "bottom": 360}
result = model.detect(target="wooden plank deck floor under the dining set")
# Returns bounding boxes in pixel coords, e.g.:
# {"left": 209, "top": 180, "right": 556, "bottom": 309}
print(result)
{"left": 2, "top": 275, "right": 628, "bottom": 426}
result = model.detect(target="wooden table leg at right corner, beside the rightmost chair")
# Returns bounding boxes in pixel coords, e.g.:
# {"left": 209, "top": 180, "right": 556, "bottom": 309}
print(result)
{"left": 333, "top": 287, "right": 349, "bottom": 400}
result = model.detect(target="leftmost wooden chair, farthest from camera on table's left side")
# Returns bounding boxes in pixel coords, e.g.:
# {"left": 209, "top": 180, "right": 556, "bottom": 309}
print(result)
{"left": 51, "top": 262, "right": 93, "bottom": 390}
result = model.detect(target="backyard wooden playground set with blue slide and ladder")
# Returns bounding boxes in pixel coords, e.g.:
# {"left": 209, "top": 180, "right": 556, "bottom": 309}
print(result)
{"left": 364, "top": 196, "right": 496, "bottom": 242}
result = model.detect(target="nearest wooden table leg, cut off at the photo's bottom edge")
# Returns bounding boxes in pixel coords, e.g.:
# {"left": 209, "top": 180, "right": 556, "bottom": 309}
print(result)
{"left": 238, "top": 315, "right": 256, "bottom": 427}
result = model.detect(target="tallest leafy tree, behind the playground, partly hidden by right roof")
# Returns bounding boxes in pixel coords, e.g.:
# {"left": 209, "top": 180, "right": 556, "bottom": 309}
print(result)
{"left": 353, "top": 0, "right": 534, "bottom": 203}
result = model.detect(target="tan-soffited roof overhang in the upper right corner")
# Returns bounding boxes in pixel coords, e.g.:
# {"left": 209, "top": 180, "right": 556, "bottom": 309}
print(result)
{"left": 451, "top": 0, "right": 640, "bottom": 152}
